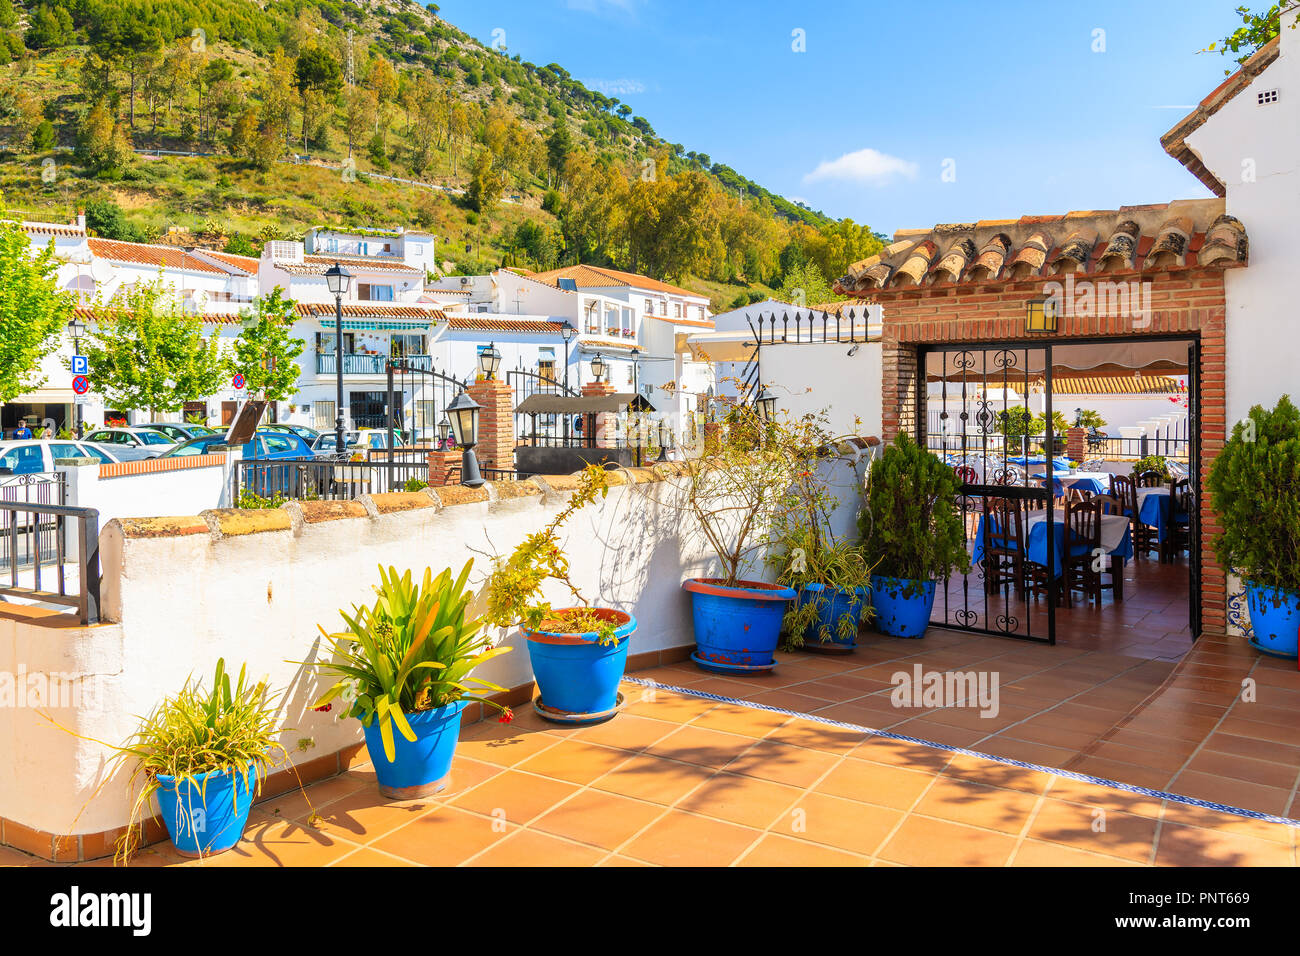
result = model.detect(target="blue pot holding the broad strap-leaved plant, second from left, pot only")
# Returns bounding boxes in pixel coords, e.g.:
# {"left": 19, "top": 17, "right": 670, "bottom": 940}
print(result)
{"left": 363, "top": 700, "right": 469, "bottom": 800}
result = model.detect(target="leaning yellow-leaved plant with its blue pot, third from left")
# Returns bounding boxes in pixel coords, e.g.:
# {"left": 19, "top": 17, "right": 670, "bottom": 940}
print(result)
{"left": 486, "top": 464, "right": 637, "bottom": 723}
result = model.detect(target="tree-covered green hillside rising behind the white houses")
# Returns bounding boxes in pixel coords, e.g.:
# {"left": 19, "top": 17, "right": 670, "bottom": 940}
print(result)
{"left": 0, "top": 0, "right": 881, "bottom": 307}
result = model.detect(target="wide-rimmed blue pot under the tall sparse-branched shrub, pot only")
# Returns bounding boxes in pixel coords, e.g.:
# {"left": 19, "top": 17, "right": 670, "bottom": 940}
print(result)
{"left": 681, "top": 578, "right": 796, "bottom": 672}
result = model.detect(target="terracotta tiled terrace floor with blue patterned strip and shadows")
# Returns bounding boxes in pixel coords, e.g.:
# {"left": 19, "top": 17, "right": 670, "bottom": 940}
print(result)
{"left": 0, "top": 630, "right": 1300, "bottom": 866}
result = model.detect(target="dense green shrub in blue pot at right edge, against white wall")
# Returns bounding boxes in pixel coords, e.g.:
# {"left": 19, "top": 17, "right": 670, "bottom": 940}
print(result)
{"left": 1206, "top": 395, "right": 1300, "bottom": 657}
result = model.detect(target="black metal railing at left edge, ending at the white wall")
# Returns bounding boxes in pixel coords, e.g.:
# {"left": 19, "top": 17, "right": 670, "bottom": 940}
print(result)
{"left": 0, "top": 501, "right": 100, "bottom": 624}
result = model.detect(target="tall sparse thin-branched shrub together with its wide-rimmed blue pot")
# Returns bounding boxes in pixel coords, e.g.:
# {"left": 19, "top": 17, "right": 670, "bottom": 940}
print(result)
{"left": 681, "top": 406, "right": 802, "bottom": 674}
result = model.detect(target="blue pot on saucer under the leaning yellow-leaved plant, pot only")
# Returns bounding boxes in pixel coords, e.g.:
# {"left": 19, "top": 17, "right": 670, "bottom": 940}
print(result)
{"left": 524, "top": 607, "right": 637, "bottom": 717}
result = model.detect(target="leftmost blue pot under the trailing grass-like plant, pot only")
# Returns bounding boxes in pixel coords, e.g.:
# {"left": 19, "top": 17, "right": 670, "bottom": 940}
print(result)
{"left": 157, "top": 766, "right": 257, "bottom": 857}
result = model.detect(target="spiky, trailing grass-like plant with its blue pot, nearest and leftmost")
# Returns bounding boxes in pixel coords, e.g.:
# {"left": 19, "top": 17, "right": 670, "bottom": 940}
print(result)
{"left": 56, "top": 658, "right": 289, "bottom": 864}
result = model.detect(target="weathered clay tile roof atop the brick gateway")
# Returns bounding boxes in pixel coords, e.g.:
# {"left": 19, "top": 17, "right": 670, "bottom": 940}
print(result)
{"left": 835, "top": 199, "right": 1249, "bottom": 298}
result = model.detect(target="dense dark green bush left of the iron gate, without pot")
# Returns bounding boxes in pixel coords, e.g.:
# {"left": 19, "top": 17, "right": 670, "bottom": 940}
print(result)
{"left": 858, "top": 432, "right": 970, "bottom": 581}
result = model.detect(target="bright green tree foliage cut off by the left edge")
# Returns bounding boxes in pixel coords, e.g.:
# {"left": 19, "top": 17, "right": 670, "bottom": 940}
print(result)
{"left": 0, "top": 222, "right": 74, "bottom": 403}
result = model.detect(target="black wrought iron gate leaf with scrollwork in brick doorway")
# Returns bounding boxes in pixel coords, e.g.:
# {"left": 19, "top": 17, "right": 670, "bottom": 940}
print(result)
{"left": 917, "top": 345, "right": 1065, "bottom": 644}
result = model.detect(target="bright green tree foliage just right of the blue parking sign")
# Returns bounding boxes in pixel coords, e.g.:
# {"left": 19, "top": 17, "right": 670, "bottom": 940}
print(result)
{"left": 82, "top": 277, "right": 229, "bottom": 414}
